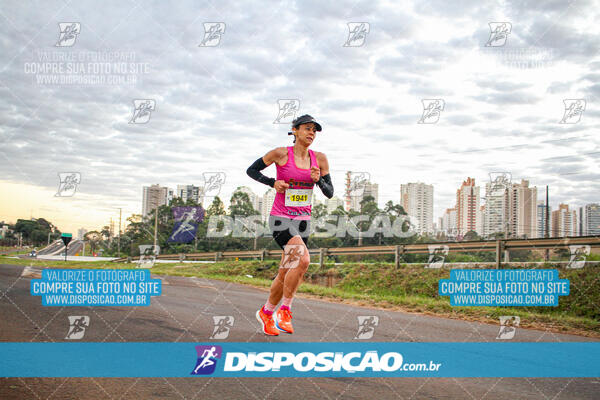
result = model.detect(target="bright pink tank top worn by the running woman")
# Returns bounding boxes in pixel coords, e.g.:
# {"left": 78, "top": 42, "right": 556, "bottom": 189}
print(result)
{"left": 271, "top": 146, "right": 319, "bottom": 220}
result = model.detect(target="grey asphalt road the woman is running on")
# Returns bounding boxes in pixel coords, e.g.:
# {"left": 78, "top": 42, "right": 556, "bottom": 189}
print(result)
{"left": 0, "top": 265, "right": 600, "bottom": 400}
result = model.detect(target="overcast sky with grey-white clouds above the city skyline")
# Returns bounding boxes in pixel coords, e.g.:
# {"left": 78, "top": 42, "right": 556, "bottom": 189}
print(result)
{"left": 0, "top": 1, "right": 600, "bottom": 231}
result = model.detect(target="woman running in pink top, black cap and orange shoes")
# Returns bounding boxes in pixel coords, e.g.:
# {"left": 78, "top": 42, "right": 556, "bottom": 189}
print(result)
{"left": 246, "top": 115, "right": 333, "bottom": 336}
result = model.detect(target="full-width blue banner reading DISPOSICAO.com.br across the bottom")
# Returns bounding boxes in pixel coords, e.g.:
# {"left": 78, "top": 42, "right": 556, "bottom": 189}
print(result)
{"left": 0, "top": 342, "right": 600, "bottom": 378}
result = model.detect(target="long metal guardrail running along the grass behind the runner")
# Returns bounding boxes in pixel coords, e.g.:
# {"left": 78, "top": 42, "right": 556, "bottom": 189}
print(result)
{"left": 114, "top": 236, "right": 600, "bottom": 268}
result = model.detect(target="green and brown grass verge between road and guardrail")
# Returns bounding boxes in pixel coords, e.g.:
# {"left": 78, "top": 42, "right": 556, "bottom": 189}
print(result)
{"left": 0, "top": 257, "right": 600, "bottom": 337}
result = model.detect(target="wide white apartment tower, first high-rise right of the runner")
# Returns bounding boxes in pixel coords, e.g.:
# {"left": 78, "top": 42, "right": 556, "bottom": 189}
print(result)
{"left": 400, "top": 182, "right": 433, "bottom": 234}
